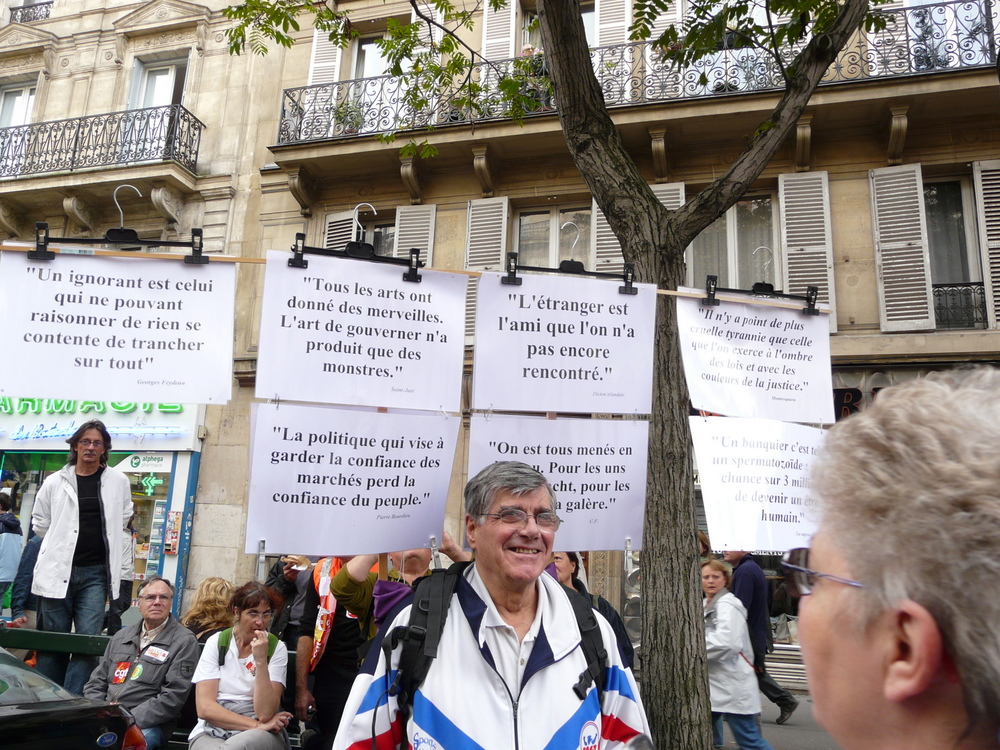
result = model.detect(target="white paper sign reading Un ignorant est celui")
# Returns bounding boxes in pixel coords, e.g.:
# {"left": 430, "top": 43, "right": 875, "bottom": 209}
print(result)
{"left": 0, "top": 251, "right": 236, "bottom": 404}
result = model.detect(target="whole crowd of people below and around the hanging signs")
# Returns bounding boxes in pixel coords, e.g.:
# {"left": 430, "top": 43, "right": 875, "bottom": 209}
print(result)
{"left": 0, "top": 368, "right": 1000, "bottom": 750}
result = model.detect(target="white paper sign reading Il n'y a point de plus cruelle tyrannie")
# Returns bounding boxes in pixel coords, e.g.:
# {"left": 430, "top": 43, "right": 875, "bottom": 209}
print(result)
{"left": 677, "top": 290, "right": 834, "bottom": 424}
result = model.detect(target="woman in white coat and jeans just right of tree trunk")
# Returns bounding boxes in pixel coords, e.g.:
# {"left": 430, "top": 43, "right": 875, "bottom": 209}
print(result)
{"left": 701, "top": 560, "right": 771, "bottom": 750}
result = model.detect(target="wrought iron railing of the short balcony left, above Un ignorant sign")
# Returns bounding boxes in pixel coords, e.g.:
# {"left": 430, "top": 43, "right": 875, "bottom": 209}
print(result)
{"left": 0, "top": 104, "right": 205, "bottom": 177}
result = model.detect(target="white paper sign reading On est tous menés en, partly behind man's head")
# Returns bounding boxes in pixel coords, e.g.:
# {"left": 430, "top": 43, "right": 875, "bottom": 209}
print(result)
{"left": 469, "top": 414, "right": 649, "bottom": 550}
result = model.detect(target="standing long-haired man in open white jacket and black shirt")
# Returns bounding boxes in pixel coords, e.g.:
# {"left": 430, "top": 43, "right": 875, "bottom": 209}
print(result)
{"left": 31, "top": 419, "right": 133, "bottom": 693}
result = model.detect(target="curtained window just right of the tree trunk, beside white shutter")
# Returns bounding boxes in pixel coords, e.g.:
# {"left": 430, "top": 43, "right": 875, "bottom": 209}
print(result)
{"left": 688, "top": 195, "right": 781, "bottom": 289}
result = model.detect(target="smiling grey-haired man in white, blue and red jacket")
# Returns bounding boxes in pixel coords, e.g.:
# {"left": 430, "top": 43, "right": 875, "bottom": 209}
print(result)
{"left": 334, "top": 461, "right": 647, "bottom": 750}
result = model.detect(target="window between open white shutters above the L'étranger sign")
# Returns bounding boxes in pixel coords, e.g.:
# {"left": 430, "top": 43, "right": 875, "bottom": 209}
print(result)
{"left": 514, "top": 206, "right": 593, "bottom": 268}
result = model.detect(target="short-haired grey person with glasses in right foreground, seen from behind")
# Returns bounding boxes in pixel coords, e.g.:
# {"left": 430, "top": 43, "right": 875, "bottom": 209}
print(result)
{"left": 785, "top": 368, "right": 1000, "bottom": 750}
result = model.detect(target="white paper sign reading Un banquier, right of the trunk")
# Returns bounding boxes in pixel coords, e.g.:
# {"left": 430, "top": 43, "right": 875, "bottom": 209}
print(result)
{"left": 691, "top": 417, "right": 824, "bottom": 552}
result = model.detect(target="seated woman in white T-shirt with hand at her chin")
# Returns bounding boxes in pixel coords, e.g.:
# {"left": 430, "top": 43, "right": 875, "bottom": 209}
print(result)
{"left": 189, "top": 581, "right": 292, "bottom": 750}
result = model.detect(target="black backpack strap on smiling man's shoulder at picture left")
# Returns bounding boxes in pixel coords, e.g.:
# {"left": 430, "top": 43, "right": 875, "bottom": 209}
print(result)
{"left": 382, "top": 562, "right": 471, "bottom": 725}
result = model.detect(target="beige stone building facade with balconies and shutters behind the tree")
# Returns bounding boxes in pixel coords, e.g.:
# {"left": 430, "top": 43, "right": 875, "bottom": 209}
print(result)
{"left": 0, "top": 0, "right": 1000, "bottom": 624}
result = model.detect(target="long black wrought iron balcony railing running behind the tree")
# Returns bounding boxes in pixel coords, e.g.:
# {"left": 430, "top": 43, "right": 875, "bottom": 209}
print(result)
{"left": 278, "top": 0, "right": 997, "bottom": 144}
